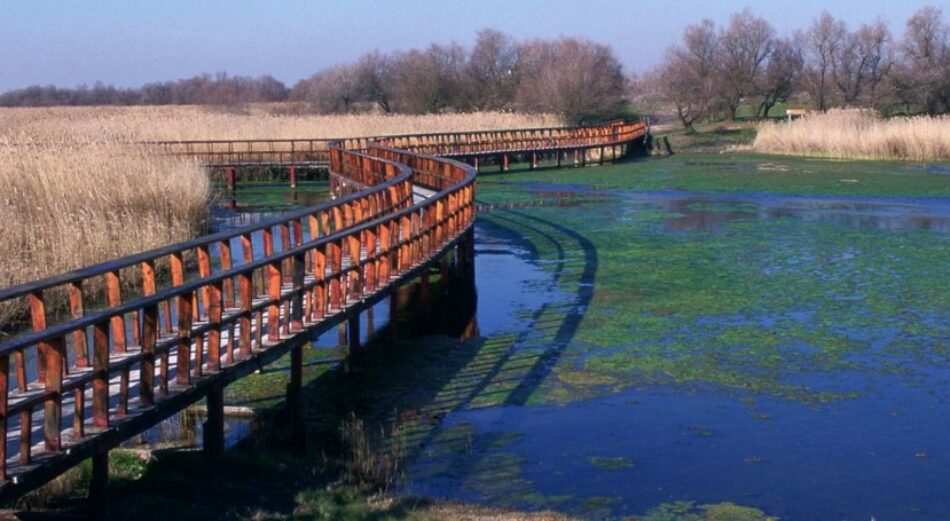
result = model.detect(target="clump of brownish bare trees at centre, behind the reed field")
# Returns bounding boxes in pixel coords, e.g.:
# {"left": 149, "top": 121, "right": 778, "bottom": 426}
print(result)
{"left": 290, "top": 29, "right": 626, "bottom": 122}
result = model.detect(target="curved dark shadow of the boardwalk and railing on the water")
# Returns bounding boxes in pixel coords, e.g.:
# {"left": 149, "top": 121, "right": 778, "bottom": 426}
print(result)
{"left": 264, "top": 203, "right": 599, "bottom": 488}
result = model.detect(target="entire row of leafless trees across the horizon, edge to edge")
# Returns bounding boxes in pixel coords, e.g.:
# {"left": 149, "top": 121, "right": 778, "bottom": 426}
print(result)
{"left": 0, "top": 7, "right": 950, "bottom": 129}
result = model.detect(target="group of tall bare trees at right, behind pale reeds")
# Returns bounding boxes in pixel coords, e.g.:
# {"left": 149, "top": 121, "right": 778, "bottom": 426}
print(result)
{"left": 648, "top": 7, "right": 950, "bottom": 129}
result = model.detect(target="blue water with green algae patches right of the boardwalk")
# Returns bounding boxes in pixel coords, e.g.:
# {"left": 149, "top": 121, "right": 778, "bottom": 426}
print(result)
{"left": 218, "top": 155, "right": 950, "bottom": 520}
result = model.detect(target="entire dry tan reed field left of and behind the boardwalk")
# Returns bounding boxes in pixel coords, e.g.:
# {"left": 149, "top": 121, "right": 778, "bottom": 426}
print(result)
{"left": 0, "top": 105, "right": 561, "bottom": 324}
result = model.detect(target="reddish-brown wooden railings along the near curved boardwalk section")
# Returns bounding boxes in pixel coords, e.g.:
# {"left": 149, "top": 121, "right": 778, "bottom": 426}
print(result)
{"left": 0, "top": 142, "right": 475, "bottom": 496}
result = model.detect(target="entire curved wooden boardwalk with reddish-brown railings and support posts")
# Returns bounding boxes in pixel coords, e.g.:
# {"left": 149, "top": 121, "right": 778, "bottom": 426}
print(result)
{"left": 0, "top": 122, "right": 646, "bottom": 505}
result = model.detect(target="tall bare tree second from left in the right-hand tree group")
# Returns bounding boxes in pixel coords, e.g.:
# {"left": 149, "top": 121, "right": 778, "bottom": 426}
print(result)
{"left": 719, "top": 9, "right": 775, "bottom": 118}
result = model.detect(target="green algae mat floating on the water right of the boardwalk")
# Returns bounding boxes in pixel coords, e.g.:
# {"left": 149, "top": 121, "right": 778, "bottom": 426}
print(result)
{"left": 479, "top": 155, "right": 950, "bottom": 402}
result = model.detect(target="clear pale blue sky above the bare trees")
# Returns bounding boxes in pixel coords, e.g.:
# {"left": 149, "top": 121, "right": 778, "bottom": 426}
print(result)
{"left": 0, "top": 0, "right": 950, "bottom": 91}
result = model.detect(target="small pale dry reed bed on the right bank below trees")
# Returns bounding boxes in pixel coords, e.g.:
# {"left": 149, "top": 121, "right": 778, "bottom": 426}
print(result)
{"left": 752, "top": 109, "right": 950, "bottom": 161}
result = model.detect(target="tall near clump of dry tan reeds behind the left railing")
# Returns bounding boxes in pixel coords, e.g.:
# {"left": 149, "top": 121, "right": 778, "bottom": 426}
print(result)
{"left": 0, "top": 136, "right": 210, "bottom": 326}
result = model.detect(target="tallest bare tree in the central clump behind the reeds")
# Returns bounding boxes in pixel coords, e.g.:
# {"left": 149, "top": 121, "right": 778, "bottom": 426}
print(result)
{"left": 468, "top": 29, "right": 518, "bottom": 110}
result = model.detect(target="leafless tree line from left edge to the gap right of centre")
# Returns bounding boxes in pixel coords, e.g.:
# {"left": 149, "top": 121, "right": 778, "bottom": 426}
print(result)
{"left": 0, "top": 33, "right": 627, "bottom": 122}
